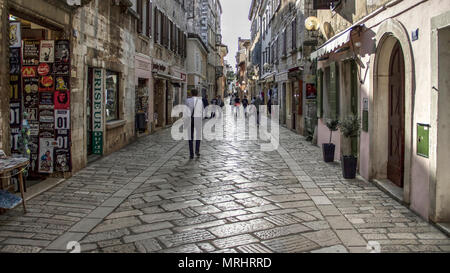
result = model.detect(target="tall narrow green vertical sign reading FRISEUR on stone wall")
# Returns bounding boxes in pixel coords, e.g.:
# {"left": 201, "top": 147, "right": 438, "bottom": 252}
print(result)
{"left": 92, "top": 69, "right": 103, "bottom": 155}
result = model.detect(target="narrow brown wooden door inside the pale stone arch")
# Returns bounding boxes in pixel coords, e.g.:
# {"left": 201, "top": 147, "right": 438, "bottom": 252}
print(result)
{"left": 388, "top": 43, "right": 405, "bottom": 187}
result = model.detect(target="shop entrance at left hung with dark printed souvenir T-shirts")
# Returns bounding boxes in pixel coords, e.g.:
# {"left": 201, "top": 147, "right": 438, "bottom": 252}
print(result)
{"left": 9, "top": 12, "right": 72, "bottom": 185}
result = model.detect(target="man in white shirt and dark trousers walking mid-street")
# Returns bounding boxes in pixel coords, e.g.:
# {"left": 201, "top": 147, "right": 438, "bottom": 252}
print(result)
{"left": 186, "top": 89, "right": 204, "bottom": 159}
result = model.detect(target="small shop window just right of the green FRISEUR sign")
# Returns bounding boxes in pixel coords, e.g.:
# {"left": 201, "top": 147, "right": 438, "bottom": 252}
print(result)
{"left": 106, "top": 71, "right": 119, "bottom": 122}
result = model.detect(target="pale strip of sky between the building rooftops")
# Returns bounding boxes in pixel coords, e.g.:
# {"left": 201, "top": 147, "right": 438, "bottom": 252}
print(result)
{"left": 220, "top": 0, "right": 251, "bottom": 69}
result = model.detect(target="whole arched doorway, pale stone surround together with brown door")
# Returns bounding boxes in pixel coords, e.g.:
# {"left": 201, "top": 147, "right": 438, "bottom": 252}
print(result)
{"left": 369, "top": 19, "right": 414, "bottom": 204}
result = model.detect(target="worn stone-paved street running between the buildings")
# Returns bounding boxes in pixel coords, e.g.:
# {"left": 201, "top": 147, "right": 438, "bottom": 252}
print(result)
{"left": 0, "top": 111, "right": 450, "bottom": 253}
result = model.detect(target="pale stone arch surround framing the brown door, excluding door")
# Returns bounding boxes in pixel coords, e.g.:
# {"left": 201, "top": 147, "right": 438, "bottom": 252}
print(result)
{"left": 369, "top": 19, "right": 415, "bottom": 204}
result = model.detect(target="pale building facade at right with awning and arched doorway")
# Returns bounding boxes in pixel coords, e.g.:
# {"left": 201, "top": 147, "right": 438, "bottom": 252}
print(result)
{"left": 311, "top": 0, "right": 450, "bottom": 223}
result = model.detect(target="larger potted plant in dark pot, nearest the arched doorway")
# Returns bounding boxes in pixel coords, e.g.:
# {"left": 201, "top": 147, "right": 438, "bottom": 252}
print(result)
{"left": 339, "top": 115, "right": 361, "bottom": 179}
